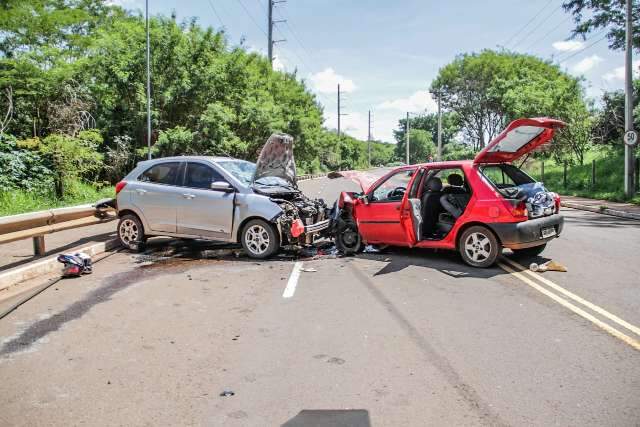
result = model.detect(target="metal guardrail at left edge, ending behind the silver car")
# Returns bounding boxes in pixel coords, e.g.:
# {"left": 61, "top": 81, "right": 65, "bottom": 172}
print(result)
{"left": 0, "top": 202, "right": 116, "bottom": 255}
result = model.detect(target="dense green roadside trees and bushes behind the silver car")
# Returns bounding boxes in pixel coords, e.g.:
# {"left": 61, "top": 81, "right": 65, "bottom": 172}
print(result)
{"left": 0, "top": 0, "right": 393, "bottom": 215}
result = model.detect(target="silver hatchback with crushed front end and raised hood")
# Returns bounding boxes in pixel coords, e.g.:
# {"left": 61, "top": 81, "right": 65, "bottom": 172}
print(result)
{"left": 116, "top": 134, "right": 330, "bottom": 258}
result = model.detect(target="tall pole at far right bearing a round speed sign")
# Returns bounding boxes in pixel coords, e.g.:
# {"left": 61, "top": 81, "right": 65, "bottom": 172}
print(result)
{"left": 624, "top": 0, "right": 638, "bottom": 197}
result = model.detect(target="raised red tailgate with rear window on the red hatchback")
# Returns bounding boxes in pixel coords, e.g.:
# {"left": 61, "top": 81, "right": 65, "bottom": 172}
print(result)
{"left": 473, "top": 117, "right": 566, "bottom": 163}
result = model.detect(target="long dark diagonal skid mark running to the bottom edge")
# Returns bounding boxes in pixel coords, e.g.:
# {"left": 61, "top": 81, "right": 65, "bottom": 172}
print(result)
{"left": 348, "top": 263, "right": 509, "bottom": 426}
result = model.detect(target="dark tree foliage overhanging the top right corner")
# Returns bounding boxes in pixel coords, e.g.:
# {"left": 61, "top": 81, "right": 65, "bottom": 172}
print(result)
{"left": 562, "top": 0, "right": 640, "bottom": 52}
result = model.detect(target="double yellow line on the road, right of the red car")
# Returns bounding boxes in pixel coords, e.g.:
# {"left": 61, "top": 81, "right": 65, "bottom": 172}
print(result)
{"left": 498, "top": 260, "right": 640, "bottom": 350}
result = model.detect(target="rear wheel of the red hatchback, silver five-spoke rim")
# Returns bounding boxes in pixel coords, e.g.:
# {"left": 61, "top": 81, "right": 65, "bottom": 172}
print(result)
{"left": 458, "top": 225, "right": 501, "bottom": 268}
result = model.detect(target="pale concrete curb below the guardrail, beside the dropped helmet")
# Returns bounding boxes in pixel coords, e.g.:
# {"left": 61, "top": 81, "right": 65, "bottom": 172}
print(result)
{"left": 0, "top": 239, "right": 120, "bottom": 292}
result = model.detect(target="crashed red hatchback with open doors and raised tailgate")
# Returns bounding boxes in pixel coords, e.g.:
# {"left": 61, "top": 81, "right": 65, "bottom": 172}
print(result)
{"left": 333, "top": 118, "right": 565, "bottom": 267}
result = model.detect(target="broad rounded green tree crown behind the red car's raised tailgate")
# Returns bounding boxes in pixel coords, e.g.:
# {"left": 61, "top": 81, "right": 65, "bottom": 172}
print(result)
{"left": 431, "top": 50, "right": 583, "bottom": 150}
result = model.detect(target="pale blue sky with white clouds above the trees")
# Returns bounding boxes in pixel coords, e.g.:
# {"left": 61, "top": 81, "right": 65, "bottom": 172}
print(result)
{"left": 111, "top": 0, "right": 640, "bottom": 141}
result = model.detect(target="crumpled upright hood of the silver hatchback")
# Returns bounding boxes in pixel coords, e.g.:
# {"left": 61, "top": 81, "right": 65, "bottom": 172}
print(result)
{"left": 252, "top": 133, "right": 298, "bottom": 188}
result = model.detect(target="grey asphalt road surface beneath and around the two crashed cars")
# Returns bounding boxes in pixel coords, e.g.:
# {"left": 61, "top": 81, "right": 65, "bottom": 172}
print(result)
{"left": 0, "top": 172, "right": 640, "bottom": 426}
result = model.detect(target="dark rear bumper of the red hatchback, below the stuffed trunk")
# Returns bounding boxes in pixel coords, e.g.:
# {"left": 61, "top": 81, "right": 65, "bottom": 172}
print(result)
{"left": 488, "top": 214, "right": 564, "bottom": 249}
